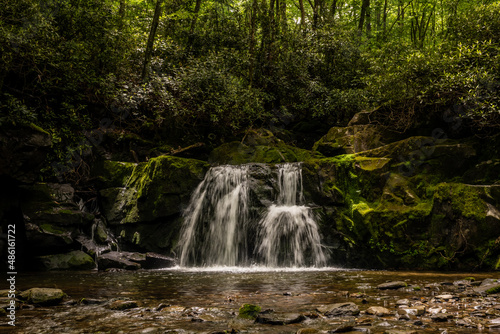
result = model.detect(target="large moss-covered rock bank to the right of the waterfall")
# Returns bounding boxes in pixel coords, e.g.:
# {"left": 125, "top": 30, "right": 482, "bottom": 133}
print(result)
{"left": 303, "top": 111, "right": 500, "bottom": 269}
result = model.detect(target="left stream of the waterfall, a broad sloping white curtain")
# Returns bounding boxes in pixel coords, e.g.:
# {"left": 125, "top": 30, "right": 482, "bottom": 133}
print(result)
{"left": 179, "top": 165, "right": 252, "bottom": 266}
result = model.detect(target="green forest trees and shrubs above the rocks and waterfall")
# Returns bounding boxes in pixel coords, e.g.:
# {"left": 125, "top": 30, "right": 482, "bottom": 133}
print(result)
{"left": 0, "top": 0, "right": 500, "bottom": 180}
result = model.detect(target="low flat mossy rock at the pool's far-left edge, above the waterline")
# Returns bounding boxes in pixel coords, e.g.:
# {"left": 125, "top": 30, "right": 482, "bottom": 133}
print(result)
{"left": 36, "top": 250, "right": 95, "bottom": 270}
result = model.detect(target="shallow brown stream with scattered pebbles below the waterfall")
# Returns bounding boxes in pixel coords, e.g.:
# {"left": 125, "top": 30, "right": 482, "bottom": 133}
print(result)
{"left": 0, "top": 267, "right": 500, "bottom": 334}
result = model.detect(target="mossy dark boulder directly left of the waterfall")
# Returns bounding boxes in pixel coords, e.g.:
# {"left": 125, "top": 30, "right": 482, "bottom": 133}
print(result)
{"left": 94, "top": 156, "right": 209, "bottom": 254}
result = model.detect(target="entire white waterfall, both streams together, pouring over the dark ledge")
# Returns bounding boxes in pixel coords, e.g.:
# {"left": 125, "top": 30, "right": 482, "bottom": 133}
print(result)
{"left": 178, "top": 163, "right": 327, "bottom": 267}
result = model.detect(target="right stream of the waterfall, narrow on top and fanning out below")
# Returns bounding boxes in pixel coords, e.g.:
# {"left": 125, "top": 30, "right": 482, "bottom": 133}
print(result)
{"left": 257, "top": 164, "right": 326, "bottom": 267}
